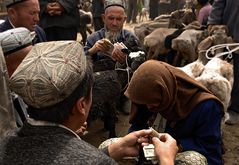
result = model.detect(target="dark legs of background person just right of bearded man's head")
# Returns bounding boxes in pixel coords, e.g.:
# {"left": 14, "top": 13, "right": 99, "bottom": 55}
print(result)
{"left": 126, "top": 0, "right": 138, "bottom": 23}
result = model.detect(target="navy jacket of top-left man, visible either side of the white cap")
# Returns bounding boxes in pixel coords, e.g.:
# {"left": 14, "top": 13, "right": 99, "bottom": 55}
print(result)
{"left": 0, "top": 19, "right": 47, "bottom": 45}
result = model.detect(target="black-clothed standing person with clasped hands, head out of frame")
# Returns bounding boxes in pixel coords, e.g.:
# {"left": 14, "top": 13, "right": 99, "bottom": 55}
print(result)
{"left": 39, "top": 0, "right": 80, "bottom": 41}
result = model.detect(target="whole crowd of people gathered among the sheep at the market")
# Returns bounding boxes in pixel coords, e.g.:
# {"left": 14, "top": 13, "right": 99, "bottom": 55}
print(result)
{"left": 0, "top": 0, "right": 239, "bottom": 165}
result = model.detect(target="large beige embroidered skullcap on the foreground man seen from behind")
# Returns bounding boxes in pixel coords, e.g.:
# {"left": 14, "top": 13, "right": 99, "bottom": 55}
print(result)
{"left": 10, "top": 41, "right": 87, "bottom": 109}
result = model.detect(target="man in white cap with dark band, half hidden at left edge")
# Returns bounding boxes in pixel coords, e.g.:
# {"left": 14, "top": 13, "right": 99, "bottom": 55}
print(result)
{"left": 0, "top": 27, "right": 35, "bottom": 126}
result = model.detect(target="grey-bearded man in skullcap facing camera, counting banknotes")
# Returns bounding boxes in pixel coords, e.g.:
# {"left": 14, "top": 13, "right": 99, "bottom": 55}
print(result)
{"left": 84, "top": 0, "right": 139, "bottom": 63}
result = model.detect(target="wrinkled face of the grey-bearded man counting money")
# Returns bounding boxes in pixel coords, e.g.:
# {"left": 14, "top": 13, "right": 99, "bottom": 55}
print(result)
{"left": 102, "top": 6, "right": 126, "bottom": 32}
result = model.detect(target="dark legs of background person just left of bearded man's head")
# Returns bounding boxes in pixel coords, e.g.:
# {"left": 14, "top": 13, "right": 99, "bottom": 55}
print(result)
{"left": 91, "top": 0, "right": 104, "bottom": 31}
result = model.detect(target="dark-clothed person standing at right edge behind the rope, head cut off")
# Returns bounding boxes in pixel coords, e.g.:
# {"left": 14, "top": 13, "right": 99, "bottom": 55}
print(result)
{"left": 208, "top": 0, "right": 239, "bottom": 125}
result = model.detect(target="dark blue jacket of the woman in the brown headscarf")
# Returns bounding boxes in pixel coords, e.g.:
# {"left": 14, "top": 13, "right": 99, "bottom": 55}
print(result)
{"left": 129, "top": 100, "right": 223, "bottom": 165}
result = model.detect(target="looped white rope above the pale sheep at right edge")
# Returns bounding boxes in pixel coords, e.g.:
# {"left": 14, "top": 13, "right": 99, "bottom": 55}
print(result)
{"left": 204, "top": 43, "right": 239, "bottom": 59}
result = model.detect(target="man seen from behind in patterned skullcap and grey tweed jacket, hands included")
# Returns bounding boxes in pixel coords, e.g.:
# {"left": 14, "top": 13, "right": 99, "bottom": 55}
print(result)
{"left": 0, "top": 41, "right": 177, "bottom": 165}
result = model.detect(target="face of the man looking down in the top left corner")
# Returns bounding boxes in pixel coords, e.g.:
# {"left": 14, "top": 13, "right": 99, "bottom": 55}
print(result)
{"left": 8, "top": 0, "right": 40, "bottom": 31}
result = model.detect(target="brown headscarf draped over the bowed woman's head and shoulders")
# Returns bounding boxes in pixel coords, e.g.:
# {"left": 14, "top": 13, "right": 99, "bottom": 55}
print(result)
{"left": 125, "top": 60, "right": 222, "bottom": 122}
